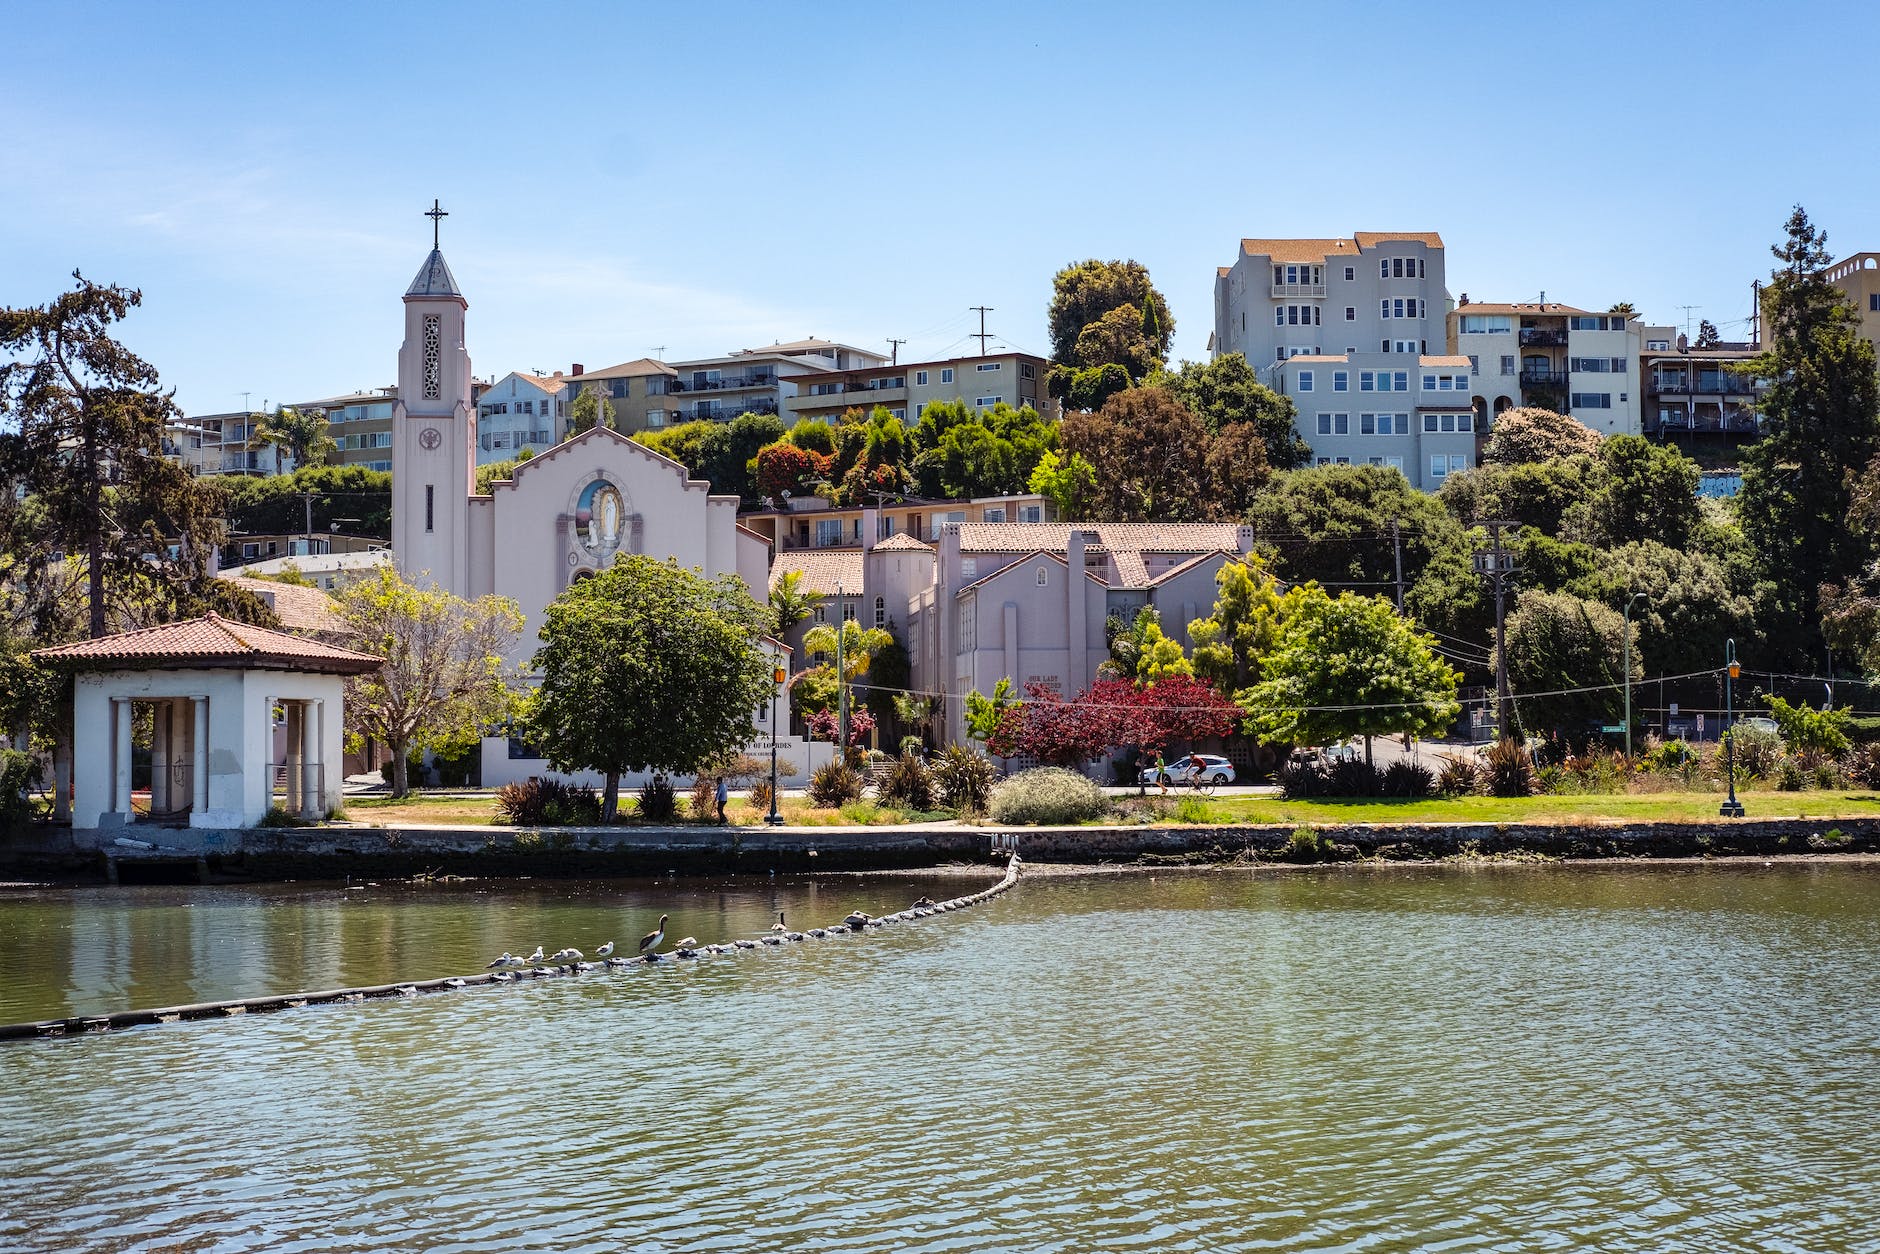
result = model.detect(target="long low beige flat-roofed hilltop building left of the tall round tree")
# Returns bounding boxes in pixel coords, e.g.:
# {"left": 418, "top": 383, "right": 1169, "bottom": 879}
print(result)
{"left": 784, "top": 352, "right": 1051, "bottom": 423}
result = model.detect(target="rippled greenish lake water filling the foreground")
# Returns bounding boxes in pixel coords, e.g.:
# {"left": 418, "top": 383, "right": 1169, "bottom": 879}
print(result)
{"left": 0, "top": 863, "right": 1880, "bottom": 1252}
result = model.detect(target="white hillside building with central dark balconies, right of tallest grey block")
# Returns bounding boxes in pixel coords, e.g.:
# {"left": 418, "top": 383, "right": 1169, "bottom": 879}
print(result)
{"left": 1448, "top": 300, "right": 1643, "bottom": 436}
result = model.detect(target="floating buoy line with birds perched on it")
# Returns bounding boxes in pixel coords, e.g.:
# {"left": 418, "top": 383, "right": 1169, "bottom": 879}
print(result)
{"left": 0, "top": 854, "right": 1019, "bottom": 1040}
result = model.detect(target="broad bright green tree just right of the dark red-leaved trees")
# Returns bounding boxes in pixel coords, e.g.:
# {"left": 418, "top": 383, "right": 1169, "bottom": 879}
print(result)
{"left": 1235, "top": 588, "right": 1461, "bottom": 763}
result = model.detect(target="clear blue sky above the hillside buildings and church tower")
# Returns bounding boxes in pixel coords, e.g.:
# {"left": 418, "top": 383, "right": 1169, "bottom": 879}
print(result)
{"left": 0, "top": 0, "right": 1880, "bottom": 414}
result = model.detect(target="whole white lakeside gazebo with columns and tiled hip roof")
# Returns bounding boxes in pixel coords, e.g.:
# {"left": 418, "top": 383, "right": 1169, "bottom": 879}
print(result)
{"left": 32, "top": 615, "right": 384, "bottom": 829}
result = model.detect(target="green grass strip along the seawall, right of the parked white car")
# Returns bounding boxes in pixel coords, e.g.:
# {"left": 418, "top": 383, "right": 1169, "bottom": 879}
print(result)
{"left": 1160, "top": 792, "right": 1880, "bottom": 823}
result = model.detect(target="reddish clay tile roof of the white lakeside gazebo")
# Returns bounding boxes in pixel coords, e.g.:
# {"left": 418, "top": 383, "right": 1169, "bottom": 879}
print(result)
{"left": 32, "top": 615, "right": 385, "bottom": 675}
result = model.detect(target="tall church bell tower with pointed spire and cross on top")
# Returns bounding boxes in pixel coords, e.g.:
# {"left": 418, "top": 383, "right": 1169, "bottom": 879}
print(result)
{"left": 391, "top": 201, "right": 476, "bottom": 598}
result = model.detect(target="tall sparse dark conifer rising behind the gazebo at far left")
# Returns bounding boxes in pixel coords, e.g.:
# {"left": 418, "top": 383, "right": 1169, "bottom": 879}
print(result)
{"left": 0, "top": 273, "right": 224, "bottom": 637}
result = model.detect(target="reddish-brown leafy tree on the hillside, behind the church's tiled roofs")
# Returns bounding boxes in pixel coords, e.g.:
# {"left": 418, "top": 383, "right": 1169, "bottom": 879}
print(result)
{"left": 1058, "top": 387, "right": 1216, "bottom": 523}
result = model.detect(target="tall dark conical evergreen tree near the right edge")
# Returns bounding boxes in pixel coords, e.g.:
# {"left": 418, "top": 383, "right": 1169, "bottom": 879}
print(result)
{"left": 1737, "top": 207, "right": 1880, "bottom": 666}
